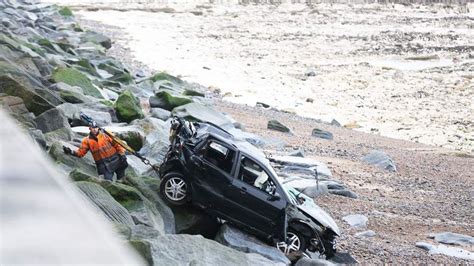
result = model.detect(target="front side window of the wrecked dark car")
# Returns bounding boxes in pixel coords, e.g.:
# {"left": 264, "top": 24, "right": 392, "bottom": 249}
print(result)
{"left": 239, "top": 156, "right": 276, "bottom": 195}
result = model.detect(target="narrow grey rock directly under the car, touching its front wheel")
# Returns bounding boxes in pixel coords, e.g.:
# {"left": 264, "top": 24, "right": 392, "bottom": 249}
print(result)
{"left": 215, "top": 224, "right": 290, "bottom": 265}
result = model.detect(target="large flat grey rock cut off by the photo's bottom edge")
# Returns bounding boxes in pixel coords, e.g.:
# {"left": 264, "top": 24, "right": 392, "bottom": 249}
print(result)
{"left": 152, "top": 235, "right": 284, "bottom": 265}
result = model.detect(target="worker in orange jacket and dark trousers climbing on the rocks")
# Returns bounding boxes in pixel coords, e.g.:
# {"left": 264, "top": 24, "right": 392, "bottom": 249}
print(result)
{"left": 63, "top": 122, "right": 128, "bottom": 181}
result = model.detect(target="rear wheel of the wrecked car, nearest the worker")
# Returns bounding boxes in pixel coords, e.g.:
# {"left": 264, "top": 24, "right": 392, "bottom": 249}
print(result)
{"left": 160, "top": 172, "right": 191, "bottom": 206}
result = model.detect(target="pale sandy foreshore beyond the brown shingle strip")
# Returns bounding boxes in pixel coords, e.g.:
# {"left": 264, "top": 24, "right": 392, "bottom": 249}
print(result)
{"left": 77, "top": 4, "right": 474, "bottom": 152}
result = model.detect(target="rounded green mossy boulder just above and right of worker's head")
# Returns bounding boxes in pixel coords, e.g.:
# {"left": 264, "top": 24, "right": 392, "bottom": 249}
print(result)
{"left": 114, "top": 90, "right": 144, "bottom": 123}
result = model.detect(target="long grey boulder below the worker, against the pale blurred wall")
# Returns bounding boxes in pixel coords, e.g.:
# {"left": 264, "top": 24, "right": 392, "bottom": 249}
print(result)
{"left": 76, "top": 181, "right": 134, "bottom": 227}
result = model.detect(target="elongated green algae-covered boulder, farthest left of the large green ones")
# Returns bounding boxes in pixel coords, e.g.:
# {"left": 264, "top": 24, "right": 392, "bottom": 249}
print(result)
{"left": 53, "top": 67, "right": 103, "bottom": 98}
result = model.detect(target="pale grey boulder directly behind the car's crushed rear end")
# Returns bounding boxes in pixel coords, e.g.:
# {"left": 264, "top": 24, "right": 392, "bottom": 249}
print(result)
{"left": 172, "top": 103, "right": 234, "bottom": 129}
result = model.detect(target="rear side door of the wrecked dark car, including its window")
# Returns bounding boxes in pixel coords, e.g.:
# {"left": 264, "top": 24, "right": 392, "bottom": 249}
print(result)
{"left": 191, "top": 139, "right": 236, "bottom": 213}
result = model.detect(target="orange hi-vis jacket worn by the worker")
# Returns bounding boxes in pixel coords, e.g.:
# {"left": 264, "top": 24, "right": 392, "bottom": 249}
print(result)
{"left": 76, "top": 131, "right": 125, "bottom": 162}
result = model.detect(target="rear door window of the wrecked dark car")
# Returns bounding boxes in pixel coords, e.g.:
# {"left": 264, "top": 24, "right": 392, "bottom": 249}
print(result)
{"left": 203, "top": 141, "right": 235, "bottom": 174}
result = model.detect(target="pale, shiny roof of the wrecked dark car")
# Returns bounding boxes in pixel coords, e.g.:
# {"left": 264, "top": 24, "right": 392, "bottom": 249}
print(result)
{"left": 197, "top": 123, "right": 270, "bottom": 167}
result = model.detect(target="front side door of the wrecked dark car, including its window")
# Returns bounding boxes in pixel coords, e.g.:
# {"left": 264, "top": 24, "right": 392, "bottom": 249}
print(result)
{"left": 226, "top": 155, "right": 286, "bottom": 235}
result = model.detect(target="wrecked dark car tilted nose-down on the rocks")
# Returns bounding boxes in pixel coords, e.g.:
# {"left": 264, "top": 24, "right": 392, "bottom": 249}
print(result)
{"left": 160, "top": 117, "right": 340, "bottom": 257}
